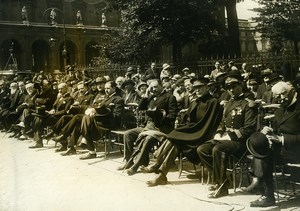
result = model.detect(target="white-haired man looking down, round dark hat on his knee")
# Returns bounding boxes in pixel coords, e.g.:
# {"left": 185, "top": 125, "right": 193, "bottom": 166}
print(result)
{"left": 244, "top": 81, "right": 300, "bottom": 207}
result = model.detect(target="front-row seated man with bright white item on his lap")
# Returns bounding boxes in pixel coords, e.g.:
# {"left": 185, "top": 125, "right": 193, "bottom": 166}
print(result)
{"left": 80, "top": 81, "right": 124, "bottom": 160}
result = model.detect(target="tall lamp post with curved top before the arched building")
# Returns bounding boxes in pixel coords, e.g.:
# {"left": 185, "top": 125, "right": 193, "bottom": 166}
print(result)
{"left": 43, "top": 7, "right": 67, "bottom": 71}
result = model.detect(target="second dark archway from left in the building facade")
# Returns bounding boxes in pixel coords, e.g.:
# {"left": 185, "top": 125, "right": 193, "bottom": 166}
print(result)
{"left": 32, "top": 40, "right": 50, "bottom": 72}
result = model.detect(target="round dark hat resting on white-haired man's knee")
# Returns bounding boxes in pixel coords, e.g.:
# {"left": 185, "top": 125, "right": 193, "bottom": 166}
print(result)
{"left": 246, "top": 132, "right": 271, "bottom": 158}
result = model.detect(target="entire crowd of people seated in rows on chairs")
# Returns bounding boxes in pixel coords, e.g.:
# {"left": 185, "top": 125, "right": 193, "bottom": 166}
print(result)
{"left": 0, "top": 62, "right": 300, "bottom": 207}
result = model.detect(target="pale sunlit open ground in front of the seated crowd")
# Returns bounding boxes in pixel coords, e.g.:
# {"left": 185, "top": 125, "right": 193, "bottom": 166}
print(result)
{"left": 0, "top": 133, "right": 300, "bottom": 211}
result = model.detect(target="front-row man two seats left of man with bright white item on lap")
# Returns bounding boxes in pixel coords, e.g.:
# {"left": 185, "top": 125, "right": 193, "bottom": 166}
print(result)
{"left": 29, "top": 83, "right": 74, "bottom": 148}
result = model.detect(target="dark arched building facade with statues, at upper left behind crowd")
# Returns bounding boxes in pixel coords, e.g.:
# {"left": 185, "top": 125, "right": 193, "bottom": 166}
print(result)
{"left": 0, "top": 0, "right": 120, "bottom": 72}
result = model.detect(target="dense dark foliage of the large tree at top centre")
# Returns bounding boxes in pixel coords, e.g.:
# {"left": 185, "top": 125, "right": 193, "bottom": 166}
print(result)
{"left": 108, "top": 0, "right": 216, "bottom": 61}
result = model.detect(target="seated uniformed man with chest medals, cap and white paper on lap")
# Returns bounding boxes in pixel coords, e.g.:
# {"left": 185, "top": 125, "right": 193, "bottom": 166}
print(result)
{"left": 197, "top": 71, "right": 257, "bottom": 198}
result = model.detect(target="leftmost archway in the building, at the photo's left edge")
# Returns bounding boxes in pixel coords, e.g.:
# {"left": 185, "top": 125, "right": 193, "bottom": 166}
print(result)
{"left": 0, "top": 39, "right": 21, "bottom": 70}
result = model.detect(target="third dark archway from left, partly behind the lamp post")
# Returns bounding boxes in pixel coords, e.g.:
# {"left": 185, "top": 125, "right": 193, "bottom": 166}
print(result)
{"left": 59, "top": 41, "right": 77, "bottom": 72}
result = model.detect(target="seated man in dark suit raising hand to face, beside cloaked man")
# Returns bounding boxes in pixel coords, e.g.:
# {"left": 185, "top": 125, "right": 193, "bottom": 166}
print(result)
{"left": 118, "top": 79, "right": 177, "bottom": 170}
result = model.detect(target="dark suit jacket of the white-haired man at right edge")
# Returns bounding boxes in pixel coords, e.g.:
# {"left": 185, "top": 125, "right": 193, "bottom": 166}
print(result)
{"left": 274, "top": 98, "right": 300, "bottom": 163}
